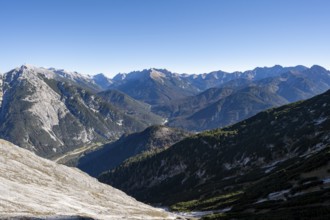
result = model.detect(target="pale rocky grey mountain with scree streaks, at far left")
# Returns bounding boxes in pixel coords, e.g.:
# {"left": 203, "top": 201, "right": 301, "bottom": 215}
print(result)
{"left": 0, "top": 66, "right": 150, "bottom": 157}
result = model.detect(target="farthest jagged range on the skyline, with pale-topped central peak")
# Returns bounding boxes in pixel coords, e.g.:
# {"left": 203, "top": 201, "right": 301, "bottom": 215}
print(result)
{"left": 108, "top": 65, "right": 307, "bottom": 105}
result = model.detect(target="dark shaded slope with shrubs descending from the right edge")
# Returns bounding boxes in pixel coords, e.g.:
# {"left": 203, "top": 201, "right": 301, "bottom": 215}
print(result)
{"left": 99, "top": 90, "right": 330, "bottom": 219}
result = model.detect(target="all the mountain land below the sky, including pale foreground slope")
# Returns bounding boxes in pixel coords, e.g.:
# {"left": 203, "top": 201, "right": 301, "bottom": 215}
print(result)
{"left": 0, "top": 65, "right": 330, "bottom": 219}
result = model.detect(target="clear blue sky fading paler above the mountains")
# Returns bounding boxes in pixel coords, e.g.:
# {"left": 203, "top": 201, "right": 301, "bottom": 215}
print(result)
{"left": 0, "top": 0, "right": 330, "bottom": 76}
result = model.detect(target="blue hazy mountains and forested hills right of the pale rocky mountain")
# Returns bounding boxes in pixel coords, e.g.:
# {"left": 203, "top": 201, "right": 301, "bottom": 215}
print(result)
{"left": 92, "top": 65, "right": 330, "bottom": 131}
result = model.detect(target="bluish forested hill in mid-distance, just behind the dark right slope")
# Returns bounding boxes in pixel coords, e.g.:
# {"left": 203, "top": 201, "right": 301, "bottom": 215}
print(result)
{"left": 168, "top": 86, "right": 288, "bottom": 131}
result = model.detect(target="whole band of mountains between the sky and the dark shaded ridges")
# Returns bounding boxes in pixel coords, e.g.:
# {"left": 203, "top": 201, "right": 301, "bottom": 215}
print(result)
{"left": 0, "top": 65, "right": 330, "bottom": 158}
